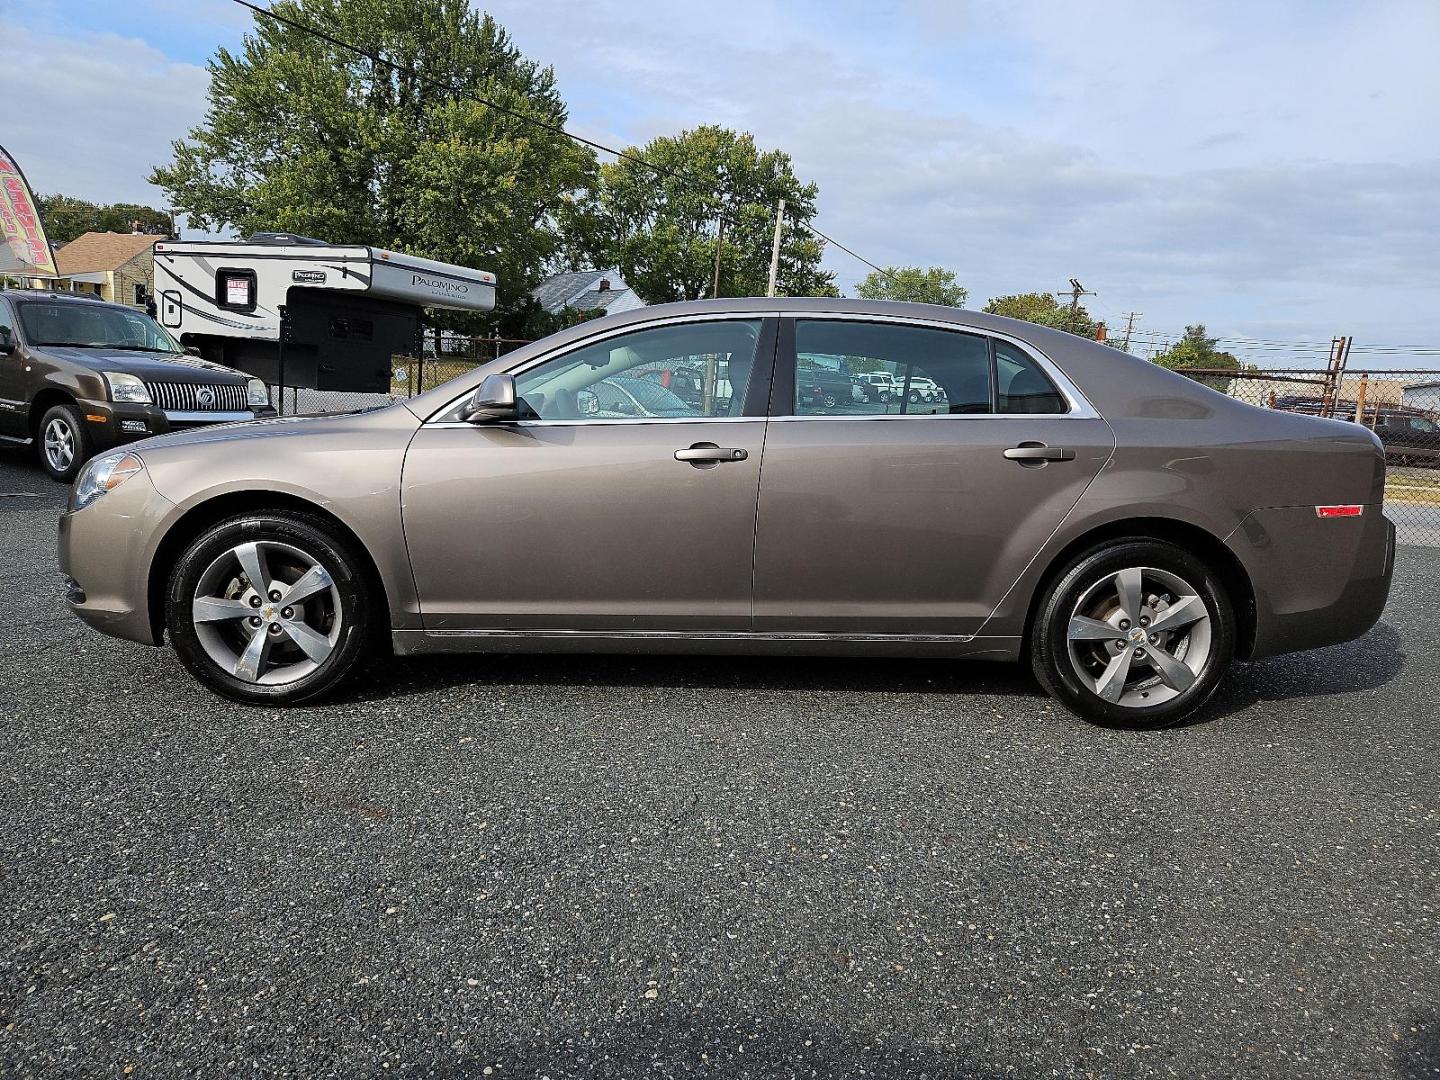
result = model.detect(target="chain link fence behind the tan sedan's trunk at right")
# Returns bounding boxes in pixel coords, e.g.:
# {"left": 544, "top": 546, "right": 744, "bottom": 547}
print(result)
{"left": 1181, "top": 369, "right": 1440, "bottom": 547}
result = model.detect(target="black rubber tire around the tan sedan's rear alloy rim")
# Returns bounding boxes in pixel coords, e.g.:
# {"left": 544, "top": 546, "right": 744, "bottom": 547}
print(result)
{"left": 1030, "top": 539, "right": 1236, "bottom": 729}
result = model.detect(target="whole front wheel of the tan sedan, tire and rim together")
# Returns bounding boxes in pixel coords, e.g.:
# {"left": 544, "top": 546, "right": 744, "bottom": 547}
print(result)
{"left": 166, "top": 513, "right": 374, "bottom": 704}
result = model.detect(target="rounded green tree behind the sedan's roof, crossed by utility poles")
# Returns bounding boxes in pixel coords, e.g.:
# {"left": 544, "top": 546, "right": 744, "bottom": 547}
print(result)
{"left": 570, "top": 125, "right": 837, "bottom": 304}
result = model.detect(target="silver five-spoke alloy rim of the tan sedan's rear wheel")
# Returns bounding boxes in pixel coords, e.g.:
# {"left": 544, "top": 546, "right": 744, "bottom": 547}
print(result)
{"left": 1066, "top": 566, "right": 1211, "bottom": 708}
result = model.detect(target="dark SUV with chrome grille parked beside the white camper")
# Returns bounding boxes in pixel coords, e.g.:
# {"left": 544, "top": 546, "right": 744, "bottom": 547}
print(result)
{"left": 0, "top": 289, "right": 275, "bottom": 482}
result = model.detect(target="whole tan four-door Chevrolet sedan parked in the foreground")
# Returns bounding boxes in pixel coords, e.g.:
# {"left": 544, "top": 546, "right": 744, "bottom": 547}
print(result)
{"left": 60, "top": 300, "right": 1394, "bottom": 727}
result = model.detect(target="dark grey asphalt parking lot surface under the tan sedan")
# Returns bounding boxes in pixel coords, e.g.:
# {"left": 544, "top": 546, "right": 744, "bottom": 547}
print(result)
{"left": 0, "top": 452, "right": 1440, "bottom": 1080}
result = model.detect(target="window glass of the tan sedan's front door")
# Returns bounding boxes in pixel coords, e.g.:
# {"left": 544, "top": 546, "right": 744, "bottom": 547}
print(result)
{"left": 516, "top": 320, "right": 760, "bottom": 420}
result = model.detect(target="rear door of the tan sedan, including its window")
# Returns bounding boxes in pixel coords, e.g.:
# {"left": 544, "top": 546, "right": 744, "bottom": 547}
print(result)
{"left": 755, "top": 315, "right": 1115, "bottom": 635}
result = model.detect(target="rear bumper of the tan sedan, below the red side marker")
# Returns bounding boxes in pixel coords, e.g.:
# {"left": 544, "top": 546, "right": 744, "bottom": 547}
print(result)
{"left": 1227, "top": 503, "right": 1395, "bottom": 658}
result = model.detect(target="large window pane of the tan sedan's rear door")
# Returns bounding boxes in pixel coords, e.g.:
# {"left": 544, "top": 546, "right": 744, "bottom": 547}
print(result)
{"left": 795, "top": 318, "right": 991, "bottom": 416}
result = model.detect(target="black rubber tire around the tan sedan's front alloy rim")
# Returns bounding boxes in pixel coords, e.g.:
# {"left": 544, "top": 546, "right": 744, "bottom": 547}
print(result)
{"left": 166, "top": 511, "right": 380, "bottom": 704}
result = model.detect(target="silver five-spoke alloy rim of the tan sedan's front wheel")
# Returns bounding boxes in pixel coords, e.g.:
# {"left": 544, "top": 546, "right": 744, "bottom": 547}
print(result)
{"left": 190, "top": 540, "right": 341, "bottom": 685}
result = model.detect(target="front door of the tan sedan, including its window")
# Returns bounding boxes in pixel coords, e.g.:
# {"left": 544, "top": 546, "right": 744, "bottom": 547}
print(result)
{"left": 403, "top": 317, "right": 776, "bottom": 635}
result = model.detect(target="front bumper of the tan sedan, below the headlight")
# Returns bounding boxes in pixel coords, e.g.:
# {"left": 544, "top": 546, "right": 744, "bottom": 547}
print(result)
{"left": 59, "top": 472, "right": 177, "bottom": 645}
